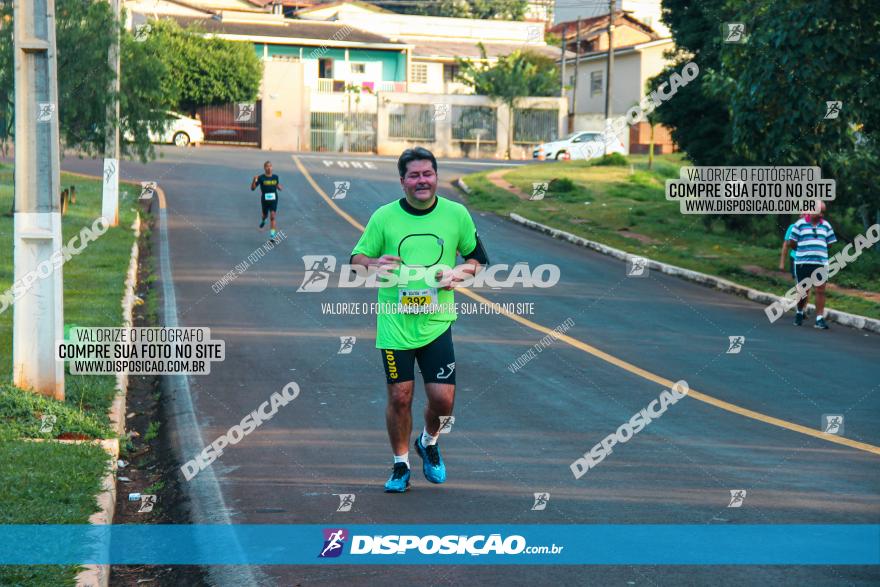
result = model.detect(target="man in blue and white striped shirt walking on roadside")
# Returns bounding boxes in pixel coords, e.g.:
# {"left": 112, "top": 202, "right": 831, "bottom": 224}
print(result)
{"left": 789, "top": 202, "right": 837, "bottom": 330}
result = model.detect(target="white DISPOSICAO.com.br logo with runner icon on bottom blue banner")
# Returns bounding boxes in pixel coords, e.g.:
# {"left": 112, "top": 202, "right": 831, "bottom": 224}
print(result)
{"left": 318, "top": 528, "right": 565, "bottom": 558}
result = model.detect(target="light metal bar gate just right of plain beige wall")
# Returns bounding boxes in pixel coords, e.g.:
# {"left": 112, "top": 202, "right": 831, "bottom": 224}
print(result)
{"left": 311, "top": 112, "right": 378, "bottom": 153}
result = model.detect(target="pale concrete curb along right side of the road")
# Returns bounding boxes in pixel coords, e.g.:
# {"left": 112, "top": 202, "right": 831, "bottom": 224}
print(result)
{"left": 508, "top": 211, "right": 880, "bottom": 333}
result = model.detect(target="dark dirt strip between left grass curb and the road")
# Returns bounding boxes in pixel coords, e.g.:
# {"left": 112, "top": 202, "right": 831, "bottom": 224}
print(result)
{"left": 110, "top": 214, "right": 208, "bottom": 587}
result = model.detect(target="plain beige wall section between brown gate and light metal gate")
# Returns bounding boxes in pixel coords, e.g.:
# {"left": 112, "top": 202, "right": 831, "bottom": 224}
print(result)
{"left": 260, "top": 60, "right": 310, "bottom": 151}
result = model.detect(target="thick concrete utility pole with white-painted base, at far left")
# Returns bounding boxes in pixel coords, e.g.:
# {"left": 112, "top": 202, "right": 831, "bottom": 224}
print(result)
{"left": 12, "top": 0, "right": 64, "bottom": 400}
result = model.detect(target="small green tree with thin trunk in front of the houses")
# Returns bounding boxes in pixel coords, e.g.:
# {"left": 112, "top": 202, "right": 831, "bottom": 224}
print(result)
{"left": 458, "top": 43, "right": 559, "bottom": 159}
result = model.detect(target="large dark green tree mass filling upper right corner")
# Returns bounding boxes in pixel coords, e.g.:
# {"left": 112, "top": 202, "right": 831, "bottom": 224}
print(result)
{"left": 650, "top": 0, "right": 880, "bottom": 234}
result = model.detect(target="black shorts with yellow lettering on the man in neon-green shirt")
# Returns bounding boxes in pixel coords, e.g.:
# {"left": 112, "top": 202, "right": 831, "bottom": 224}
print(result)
{"left": 379, "top": 323, "right": 455, "bottom": 385}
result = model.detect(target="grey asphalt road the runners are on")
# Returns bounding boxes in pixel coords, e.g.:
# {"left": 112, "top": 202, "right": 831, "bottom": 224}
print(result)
{"left": 63, "top": 148, "right": 880, "bottom": 585}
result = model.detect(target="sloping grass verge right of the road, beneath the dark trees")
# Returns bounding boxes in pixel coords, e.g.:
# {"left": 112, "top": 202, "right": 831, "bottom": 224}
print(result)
{"left": 464, "top": 154, "right": 880, "bottom": 319}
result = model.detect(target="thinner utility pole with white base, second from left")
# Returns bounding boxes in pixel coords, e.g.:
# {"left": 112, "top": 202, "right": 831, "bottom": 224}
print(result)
{"left": 101, "top": 0, "right": 121, "bottom": 226}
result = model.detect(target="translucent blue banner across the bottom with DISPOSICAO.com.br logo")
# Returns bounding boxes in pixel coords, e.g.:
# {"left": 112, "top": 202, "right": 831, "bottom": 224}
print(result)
{"left": 0, "top": 524, "right": 880, "bottom": 565}
